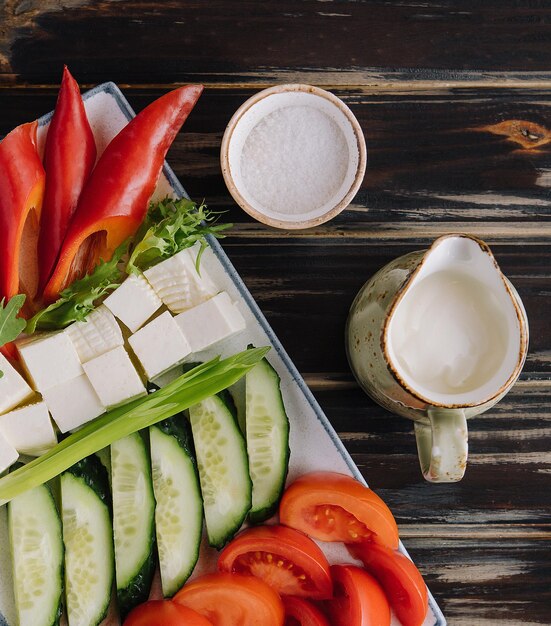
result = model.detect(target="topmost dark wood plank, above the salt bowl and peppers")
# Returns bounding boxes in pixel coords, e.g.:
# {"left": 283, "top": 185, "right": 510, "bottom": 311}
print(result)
{"left": 4, "top": 0, "right": 551, "bottom": 84}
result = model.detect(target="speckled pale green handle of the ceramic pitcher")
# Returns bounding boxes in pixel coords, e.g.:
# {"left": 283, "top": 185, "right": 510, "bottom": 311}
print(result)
{"left": 415, "top": 409, "right": 469, "bottom": 483}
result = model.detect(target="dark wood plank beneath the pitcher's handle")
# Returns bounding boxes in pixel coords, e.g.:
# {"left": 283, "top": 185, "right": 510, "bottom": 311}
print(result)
{"left": 314, "top": 381, "right": 551, "bottom": 524}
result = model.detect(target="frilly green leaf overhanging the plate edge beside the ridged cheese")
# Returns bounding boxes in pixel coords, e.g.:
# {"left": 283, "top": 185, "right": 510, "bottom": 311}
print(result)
{"left": 126, "top": 197, "right": 231, "bottom": 274}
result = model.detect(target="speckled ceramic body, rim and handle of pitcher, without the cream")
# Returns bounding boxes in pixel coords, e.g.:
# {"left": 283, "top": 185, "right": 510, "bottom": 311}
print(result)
{"left": 346, "top": 234, "right": 528, "bottom": 482}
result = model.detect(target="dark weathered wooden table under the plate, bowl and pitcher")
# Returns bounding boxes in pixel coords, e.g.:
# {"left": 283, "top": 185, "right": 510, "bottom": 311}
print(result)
{"left": 0, "top": 0, "right": 551, "bottom": 626}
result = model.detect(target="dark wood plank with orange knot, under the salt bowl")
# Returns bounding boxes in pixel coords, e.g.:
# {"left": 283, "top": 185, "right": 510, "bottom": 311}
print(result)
{"left": 0, "top": 83, "right": 551, "bottom": 228}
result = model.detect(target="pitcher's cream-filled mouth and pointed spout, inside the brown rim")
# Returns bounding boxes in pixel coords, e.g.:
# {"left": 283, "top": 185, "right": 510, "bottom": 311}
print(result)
{"left": 381, "top": 234, "right": 528, "bottom": 408}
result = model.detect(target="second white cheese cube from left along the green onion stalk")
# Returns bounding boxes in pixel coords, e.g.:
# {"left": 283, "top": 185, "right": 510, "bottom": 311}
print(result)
{"left": 0, "top": 402, "right": 57, "bottom": 456}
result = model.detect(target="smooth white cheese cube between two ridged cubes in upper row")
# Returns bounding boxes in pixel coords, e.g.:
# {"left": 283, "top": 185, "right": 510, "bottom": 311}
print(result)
{"left": 103, "top": 275, "right": 162, "bottom": 333}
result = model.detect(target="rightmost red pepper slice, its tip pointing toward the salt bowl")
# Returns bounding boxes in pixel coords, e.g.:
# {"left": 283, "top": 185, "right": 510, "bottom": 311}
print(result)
{"left": 44, "top": 85, "right": 203, "bottom": 301}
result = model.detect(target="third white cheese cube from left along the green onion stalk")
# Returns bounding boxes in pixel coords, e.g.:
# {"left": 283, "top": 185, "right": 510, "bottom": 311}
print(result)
{"left": 42, "top": 374, "right": 105, "bottom": 433}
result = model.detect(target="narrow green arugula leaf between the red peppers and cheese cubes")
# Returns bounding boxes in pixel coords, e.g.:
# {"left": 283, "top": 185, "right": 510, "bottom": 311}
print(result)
{"left": 26, "top": 242, "right": 128, "bottom": 333}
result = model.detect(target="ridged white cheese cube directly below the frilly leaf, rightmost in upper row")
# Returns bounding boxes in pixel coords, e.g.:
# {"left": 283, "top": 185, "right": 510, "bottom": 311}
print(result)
{"left": 144, "top": 246, "right": 219, "bottom": 313}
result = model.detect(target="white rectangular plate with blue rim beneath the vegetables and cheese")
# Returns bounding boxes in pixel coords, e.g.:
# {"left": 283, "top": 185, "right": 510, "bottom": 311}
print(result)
{"left": 0, "top": 82, "right": 446, "bottom": 626}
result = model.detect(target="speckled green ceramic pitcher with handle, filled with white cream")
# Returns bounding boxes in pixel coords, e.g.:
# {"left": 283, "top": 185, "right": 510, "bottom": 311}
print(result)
{"left": 346, "top": 234, "right": 528, "bottom": 482}
